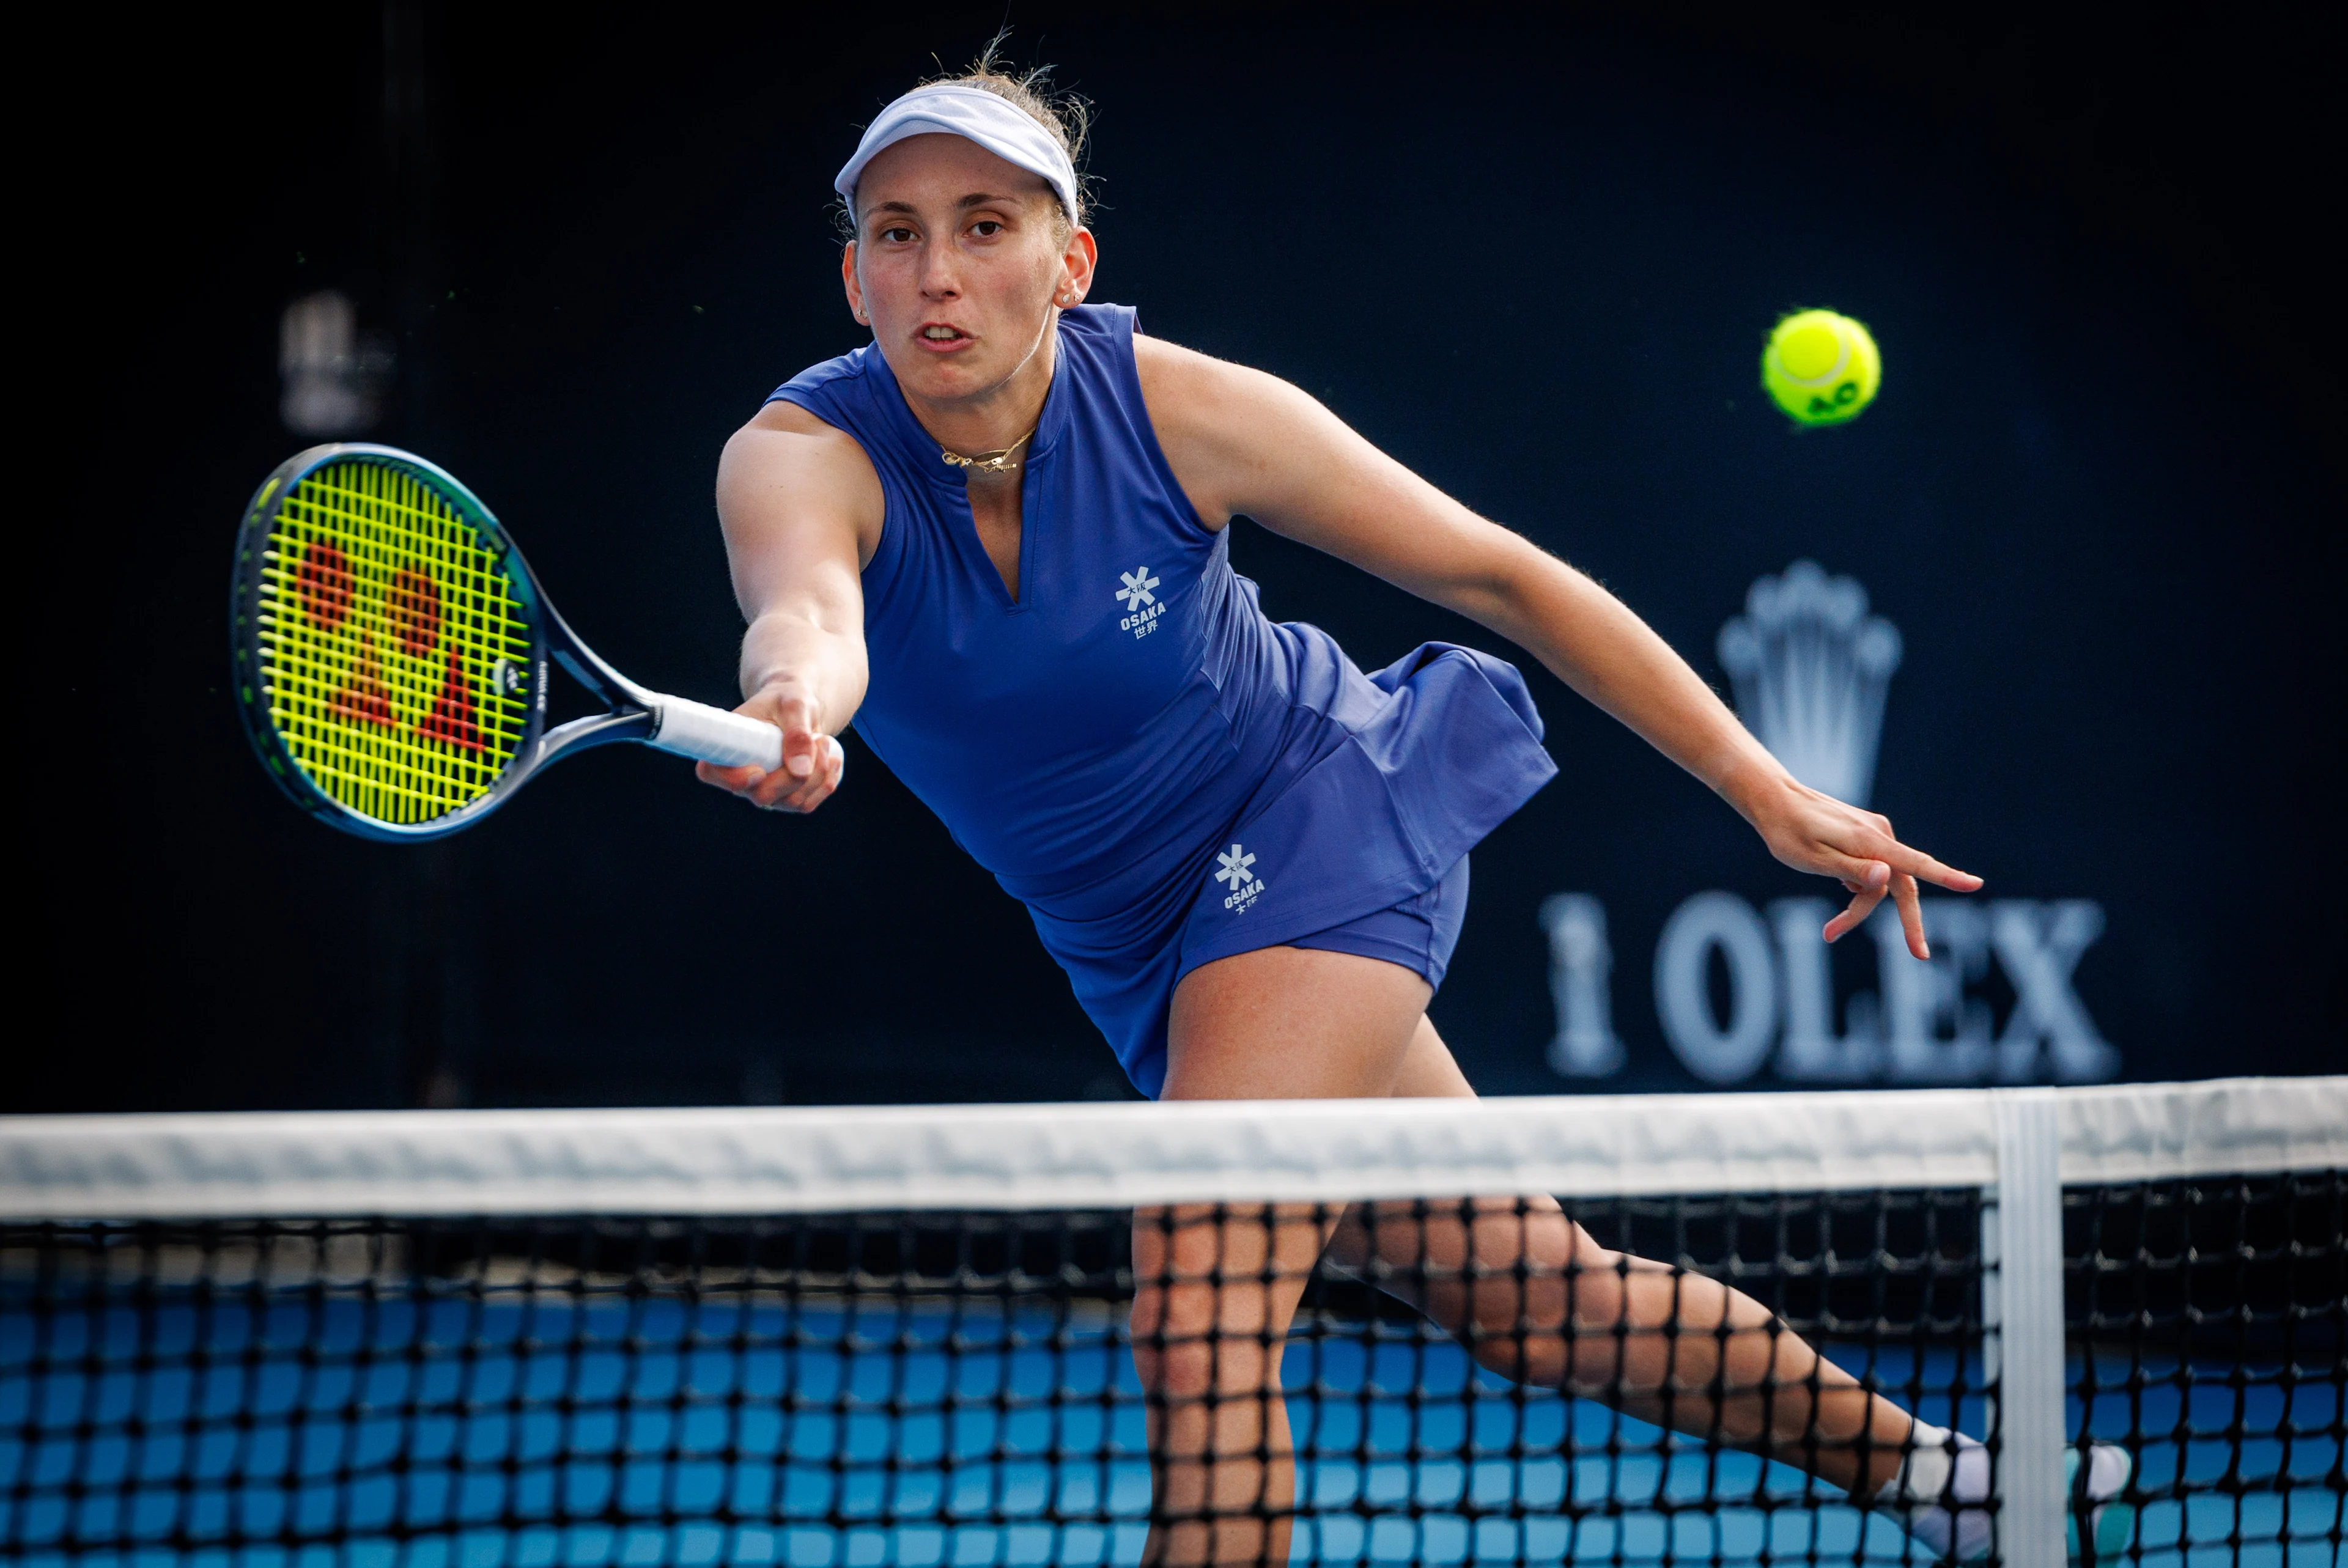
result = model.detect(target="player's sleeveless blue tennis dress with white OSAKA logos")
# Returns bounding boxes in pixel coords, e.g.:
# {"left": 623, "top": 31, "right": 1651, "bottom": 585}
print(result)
{"left": 775, "top": 305, "right": 1557, "bottom": 1099}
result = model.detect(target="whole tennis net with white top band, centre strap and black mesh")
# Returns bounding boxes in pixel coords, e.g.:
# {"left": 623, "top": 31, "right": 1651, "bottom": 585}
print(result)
{"left": 0, "top": 1077, "right": 2348, "bottom": 1568}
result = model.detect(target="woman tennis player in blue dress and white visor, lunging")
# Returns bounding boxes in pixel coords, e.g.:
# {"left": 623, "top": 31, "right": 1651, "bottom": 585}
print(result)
{"left": 700, "top": 59, "right": 2132, "bottom": 1563}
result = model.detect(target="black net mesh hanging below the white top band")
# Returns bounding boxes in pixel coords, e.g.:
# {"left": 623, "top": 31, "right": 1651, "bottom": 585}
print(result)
{"left": 0, "top": 1174, "right": 2348, "bottom": 1568}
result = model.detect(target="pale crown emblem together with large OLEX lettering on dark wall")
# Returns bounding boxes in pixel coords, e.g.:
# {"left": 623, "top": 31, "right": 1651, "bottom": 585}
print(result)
{"left": 1540, "top": 561, "right": 2121, "bottom": 1084}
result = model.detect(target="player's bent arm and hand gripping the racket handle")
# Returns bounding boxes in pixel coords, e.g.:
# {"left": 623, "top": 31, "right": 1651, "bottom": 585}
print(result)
{"left": 695, "top": 403, "right": 883, "bottom": 812}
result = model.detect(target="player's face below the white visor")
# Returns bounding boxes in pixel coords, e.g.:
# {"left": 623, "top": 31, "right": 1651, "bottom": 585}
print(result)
{"left": 841, "top": 134, "right": 1092, "bottom": 402}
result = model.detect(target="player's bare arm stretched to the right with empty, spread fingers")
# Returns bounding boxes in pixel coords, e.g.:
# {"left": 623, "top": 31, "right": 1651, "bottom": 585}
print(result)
{"left": 1137, "top": 338, "right": 1982, "bottom": 958}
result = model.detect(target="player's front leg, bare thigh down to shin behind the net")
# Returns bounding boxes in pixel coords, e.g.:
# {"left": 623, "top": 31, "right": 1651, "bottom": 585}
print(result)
{"left": 1132, "top": 948, "right": 1430, "bottom": 1566}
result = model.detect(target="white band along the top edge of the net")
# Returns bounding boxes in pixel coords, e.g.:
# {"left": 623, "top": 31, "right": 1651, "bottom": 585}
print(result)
{"left": 0, "top": 1077, "right": 2348, "bottom": 1218}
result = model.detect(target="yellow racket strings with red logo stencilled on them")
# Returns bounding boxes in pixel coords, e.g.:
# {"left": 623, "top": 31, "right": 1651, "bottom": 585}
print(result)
{"left": 260, "top": 460, "right": 536, "bottom": 824}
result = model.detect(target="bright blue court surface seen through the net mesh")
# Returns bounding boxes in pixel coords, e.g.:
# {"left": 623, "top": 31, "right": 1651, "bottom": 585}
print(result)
{"left": 0, "top": 1279, "right": 2343, "bottom": 1568}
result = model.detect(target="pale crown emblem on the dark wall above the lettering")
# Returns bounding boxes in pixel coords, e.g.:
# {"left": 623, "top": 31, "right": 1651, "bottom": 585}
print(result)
{"left": 1719, "top": 561, "right": 1900, "bottom": 805}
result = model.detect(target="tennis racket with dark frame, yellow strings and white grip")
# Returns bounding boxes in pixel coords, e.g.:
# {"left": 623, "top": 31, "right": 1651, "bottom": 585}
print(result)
{"left": 230, "top": 444, "right": 817, "bottom": 841}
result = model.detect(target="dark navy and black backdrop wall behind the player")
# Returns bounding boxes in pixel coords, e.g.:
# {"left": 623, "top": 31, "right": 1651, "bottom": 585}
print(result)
{"left": 23, "top": 5, "right": 2343, "bottom": 1110}
